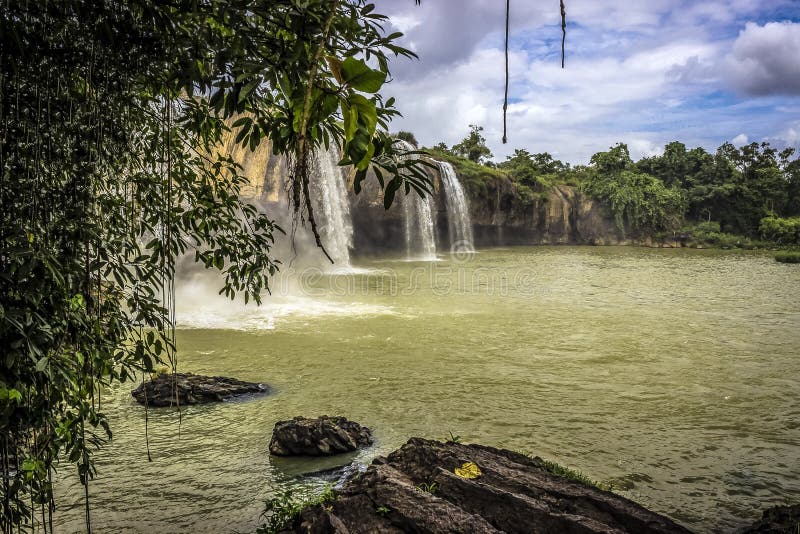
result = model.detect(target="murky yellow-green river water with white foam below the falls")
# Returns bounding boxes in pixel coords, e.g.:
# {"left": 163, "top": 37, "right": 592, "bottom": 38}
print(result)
{"left": 55, "top": 247, "right": 800, "bottom": 532}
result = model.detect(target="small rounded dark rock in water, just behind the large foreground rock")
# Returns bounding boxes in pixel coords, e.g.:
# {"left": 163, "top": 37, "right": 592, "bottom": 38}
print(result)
{"left": 269, "top": 415, "right": 372, "bottom": 456}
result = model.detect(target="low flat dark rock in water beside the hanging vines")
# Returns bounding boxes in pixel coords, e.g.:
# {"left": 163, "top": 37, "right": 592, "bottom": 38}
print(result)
{"left": 131, "top": 373, "right": 269, "bottom": 407}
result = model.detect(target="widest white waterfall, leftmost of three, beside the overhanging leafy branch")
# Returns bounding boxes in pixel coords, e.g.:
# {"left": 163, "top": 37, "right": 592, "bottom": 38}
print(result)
{"left": 313, "top": 148, "right": 353, "bottom": 267}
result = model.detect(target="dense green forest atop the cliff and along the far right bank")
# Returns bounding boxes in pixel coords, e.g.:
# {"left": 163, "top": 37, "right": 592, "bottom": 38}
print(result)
{"left": 428, "top": 125, "right": 800, "bottom": 247}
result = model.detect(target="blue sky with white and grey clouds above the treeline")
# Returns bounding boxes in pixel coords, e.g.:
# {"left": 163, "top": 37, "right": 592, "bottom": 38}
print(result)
{"left": 373, "top": 0, "right": 800, "bottom": 164}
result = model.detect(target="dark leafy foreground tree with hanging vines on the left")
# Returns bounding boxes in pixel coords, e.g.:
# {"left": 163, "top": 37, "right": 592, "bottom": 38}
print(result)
{"left": 0, "top": 0, "right": 431, "bottom": 532}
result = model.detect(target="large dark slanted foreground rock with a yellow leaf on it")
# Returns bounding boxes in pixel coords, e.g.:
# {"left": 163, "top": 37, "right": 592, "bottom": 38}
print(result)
{"left": 292, "top": 438, "right": 688, "bottom": 534}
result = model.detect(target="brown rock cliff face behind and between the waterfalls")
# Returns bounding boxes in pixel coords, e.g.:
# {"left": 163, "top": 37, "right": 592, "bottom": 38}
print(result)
{"left": 241, "top": 151, "right": 624, "bottom": 256}
